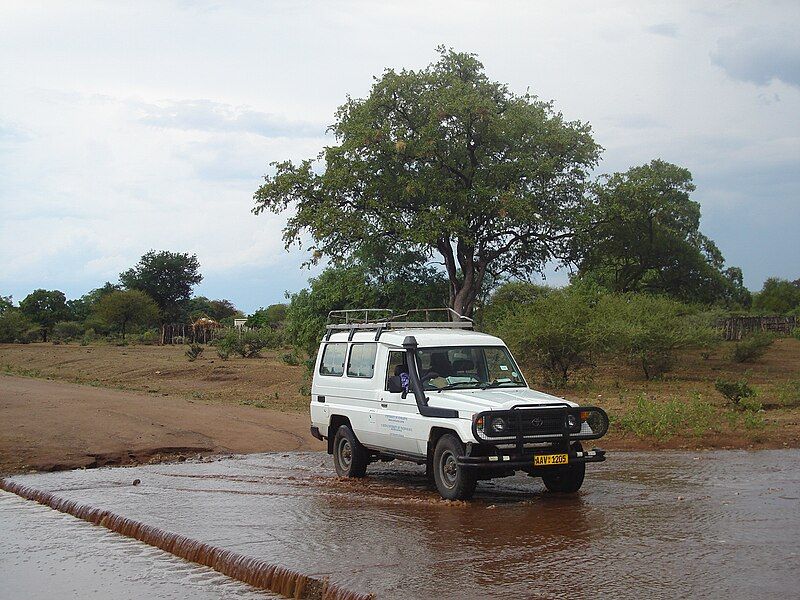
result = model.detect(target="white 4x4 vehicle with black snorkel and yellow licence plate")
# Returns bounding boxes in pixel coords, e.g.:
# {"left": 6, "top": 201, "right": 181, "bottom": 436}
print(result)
{"left": 311, "top": 310, "right": 608, "bottom": 499}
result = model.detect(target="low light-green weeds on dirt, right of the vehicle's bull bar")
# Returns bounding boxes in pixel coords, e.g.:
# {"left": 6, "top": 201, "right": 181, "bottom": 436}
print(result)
{"left": 619, "top": 394, "right": 719, "bottom": 440}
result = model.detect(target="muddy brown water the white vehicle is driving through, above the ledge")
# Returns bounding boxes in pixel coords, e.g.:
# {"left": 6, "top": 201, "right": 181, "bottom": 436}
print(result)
{"left": 1, "top": 450, "right": 800, "bottom": 599}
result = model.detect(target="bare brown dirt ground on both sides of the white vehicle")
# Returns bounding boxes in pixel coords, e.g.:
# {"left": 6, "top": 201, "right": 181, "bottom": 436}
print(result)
{"left": 0, "top": 338, "right": 800, "bottom": 472}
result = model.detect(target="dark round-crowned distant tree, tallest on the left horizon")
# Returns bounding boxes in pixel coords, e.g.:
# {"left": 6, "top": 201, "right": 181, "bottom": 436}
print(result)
{"left": 119, "top": 250, "right": 203, "bottom": 321}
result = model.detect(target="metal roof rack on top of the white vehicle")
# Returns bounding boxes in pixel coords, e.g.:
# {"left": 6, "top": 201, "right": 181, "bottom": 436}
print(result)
{"left": 325, "top": 308, "right": 475, "bottom": 341}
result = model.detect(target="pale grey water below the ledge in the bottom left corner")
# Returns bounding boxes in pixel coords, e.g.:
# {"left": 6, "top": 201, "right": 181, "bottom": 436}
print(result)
{"left": 0, "top": 491, "right": 281, "bottom": 600}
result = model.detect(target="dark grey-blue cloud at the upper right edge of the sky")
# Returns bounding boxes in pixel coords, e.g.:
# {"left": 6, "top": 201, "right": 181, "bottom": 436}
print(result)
{"left": 711, "top": 29, "right": 800, "bottom": 87}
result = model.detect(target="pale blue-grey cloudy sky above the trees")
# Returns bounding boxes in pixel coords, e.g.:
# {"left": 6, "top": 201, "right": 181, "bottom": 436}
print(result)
{"left": 0, "top": 0, "right": 800, "bottom": 312}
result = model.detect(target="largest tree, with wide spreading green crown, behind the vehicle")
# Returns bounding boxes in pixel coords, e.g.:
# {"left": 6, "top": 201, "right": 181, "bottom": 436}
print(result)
{"left": 254, "top": 48, "right": 600, "bottom": 314}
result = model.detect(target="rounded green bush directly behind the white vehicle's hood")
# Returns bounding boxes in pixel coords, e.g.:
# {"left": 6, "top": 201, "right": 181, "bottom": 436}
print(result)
{"left": 496, "top": 288, "right": 602, "bottom": 386}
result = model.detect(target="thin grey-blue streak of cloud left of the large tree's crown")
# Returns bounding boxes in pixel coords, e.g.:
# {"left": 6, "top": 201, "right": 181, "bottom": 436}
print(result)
{"left": 135, "top": 100, "right": 325, "bottom": 138}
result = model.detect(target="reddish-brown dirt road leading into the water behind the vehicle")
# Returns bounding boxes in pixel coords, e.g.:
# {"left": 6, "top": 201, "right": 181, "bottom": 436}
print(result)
{"left": 0, "top": 375, "right": 320, "bottom": 473}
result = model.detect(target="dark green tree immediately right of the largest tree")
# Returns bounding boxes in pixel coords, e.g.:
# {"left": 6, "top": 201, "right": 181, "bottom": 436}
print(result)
{"left": 572, "top": 160, "right": 750, "bottom": 306}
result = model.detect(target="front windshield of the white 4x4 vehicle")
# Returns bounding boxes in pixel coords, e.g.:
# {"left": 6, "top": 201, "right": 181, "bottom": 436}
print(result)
{"left": 417, "top": 346, "right": 525, "bottom": 391}
